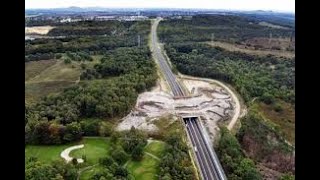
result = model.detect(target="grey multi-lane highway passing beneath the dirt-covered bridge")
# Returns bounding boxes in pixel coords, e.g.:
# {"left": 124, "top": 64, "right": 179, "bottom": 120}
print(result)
{"left": 151, "top": 18, "right": 227, "bottom": 180}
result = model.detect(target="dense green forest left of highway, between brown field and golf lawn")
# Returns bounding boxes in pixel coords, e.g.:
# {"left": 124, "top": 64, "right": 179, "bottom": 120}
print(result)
{"left": 25, "top": 47, "right": 157, "bottom": 144}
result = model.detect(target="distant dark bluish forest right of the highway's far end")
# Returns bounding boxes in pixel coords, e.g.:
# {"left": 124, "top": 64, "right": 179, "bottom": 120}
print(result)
{"left": 158, "top": 15, "right": 294, "bottom": 44}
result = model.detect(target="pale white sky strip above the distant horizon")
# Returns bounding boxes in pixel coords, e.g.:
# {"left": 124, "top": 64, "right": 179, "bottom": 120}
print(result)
{"left": 25, "top": 0, "right": 295, "bottom": 12}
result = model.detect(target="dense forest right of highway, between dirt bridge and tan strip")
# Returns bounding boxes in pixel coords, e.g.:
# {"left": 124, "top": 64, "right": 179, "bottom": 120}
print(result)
{"left": 166, "top": 43, "right": 295, "bottom": 104}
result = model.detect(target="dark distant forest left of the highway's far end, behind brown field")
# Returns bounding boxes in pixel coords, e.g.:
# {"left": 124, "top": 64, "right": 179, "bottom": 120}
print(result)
{"left": 25, "top": 21, "right": 150, "bottom": 62}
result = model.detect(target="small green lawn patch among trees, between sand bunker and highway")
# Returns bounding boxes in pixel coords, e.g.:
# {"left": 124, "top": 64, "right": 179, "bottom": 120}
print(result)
{"left": 127, "top": 141, "right": 165, "bottom": 180}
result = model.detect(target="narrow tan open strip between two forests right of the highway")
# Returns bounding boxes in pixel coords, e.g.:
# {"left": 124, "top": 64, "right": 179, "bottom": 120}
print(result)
{"left": 207, "top": 41, "right": 295, "bottom": 58}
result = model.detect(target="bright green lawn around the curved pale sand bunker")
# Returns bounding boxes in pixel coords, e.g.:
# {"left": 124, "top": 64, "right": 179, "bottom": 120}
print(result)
{"left": 25, "top": 137, "right": 110, "bottom": 165}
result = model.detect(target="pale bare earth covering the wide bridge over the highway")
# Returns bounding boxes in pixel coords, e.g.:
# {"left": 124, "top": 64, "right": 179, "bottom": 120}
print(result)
{"left": 117, "top": 76, "right": 240, "bottom": 140}
